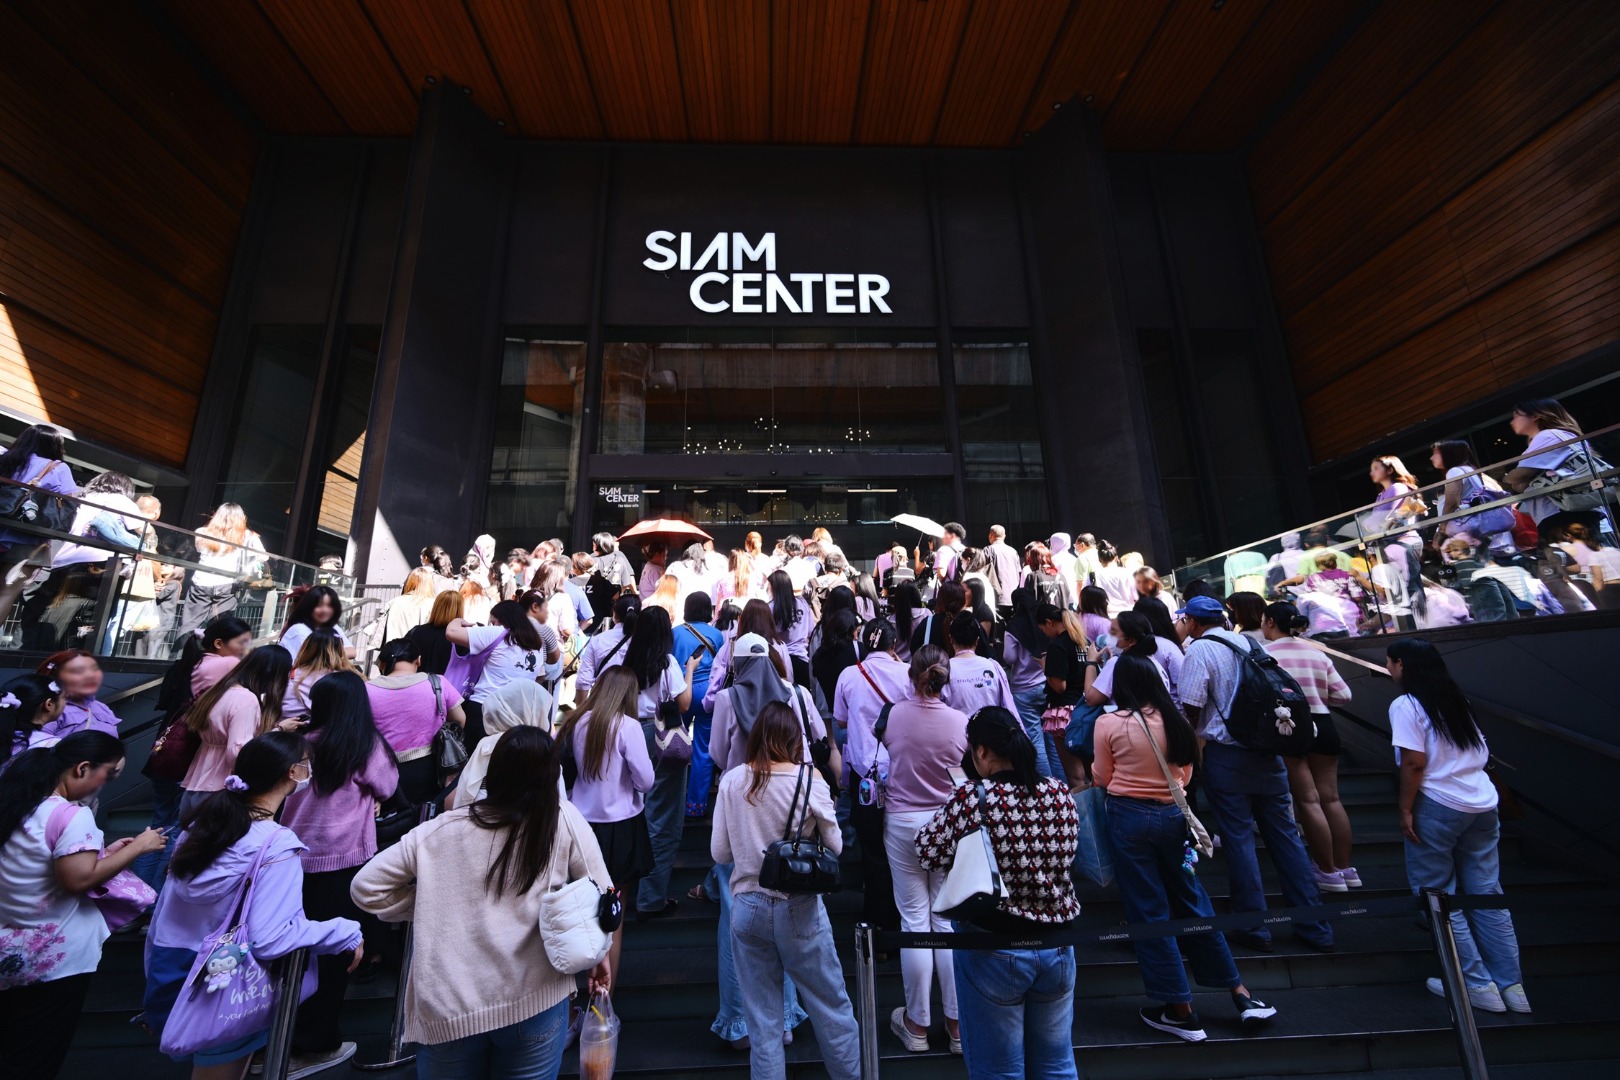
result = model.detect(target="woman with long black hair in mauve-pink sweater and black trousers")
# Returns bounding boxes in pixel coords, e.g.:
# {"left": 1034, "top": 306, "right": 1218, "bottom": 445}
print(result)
{"left": 282, "top": 672, "right": 400, "bottom": 1056}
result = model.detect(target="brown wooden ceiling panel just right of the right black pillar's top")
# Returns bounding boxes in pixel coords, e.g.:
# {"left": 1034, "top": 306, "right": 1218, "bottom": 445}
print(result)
{"left": 1103, "top": 0, "right": 1270, "bottom": 151}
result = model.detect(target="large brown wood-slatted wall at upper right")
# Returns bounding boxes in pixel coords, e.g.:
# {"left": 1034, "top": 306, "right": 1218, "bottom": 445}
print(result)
{"left": 1247, "top": 0, "right": 1620, "bottom": 461}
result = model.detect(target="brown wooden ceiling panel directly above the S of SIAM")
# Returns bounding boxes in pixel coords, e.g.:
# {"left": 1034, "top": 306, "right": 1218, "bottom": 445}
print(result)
{"left": 569, "top": 0, "right": 689, "bottom": 141}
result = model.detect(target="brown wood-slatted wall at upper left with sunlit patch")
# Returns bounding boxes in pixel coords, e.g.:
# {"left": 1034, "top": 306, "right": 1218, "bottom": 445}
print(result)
{"left": 0, "top": 0, "right": 259, "bottom": 472}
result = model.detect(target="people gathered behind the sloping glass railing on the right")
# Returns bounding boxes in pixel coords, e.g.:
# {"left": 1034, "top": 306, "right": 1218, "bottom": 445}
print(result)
{"left": 1218, "top": 398, "right": 1620, "bottom": 641}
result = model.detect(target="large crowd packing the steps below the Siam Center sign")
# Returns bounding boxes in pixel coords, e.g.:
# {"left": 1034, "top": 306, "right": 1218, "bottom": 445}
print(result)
{"left": 0, "top": 401, "right": 1568, "bottom": 1080}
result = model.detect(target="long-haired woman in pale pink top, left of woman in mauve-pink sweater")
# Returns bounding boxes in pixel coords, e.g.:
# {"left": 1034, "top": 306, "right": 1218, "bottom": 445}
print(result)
{"left": 180, "top": 644, "right": 300, "bottom": 824}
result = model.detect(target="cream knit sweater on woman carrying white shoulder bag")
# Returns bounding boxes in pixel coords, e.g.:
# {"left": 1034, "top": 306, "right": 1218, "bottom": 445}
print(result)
{"left": 350, "top": 803, "right": 612, "bottom": 1046}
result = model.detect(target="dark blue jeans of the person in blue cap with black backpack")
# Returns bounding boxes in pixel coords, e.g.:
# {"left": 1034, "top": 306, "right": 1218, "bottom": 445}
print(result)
{"left": 1200, "top": 742, "right": 1333, "bottom": 946}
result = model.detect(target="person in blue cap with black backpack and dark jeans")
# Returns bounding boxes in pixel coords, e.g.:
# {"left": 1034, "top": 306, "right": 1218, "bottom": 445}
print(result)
{"left": 1176, "top": 596, "right": 1333, "bottom": 952}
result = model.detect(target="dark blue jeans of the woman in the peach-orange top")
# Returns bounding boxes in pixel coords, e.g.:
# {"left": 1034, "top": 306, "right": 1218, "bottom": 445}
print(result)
{"left": 1108, "top": 795, "right": 1243, "bottom": 1006}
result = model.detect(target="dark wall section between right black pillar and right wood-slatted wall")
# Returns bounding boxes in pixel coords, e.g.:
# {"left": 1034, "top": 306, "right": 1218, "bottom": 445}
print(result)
{"left": 1108, "top": 154, "right": 1309, "bottom": 559}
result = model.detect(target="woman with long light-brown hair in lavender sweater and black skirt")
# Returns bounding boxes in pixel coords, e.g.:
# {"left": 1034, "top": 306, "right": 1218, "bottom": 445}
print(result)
{"left": 557, "top": 664, "right": 656, "bottom": 989}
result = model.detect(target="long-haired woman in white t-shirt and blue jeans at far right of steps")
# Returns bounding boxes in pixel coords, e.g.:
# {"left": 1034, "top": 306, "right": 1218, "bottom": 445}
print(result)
{"left": 1383, "top": 638, "right": 1529, "bottom": 1012}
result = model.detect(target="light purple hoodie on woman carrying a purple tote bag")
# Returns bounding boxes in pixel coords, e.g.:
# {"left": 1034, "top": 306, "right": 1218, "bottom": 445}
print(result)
{"left": 147, "top": 821, "right": 360, "bottom": 960}
